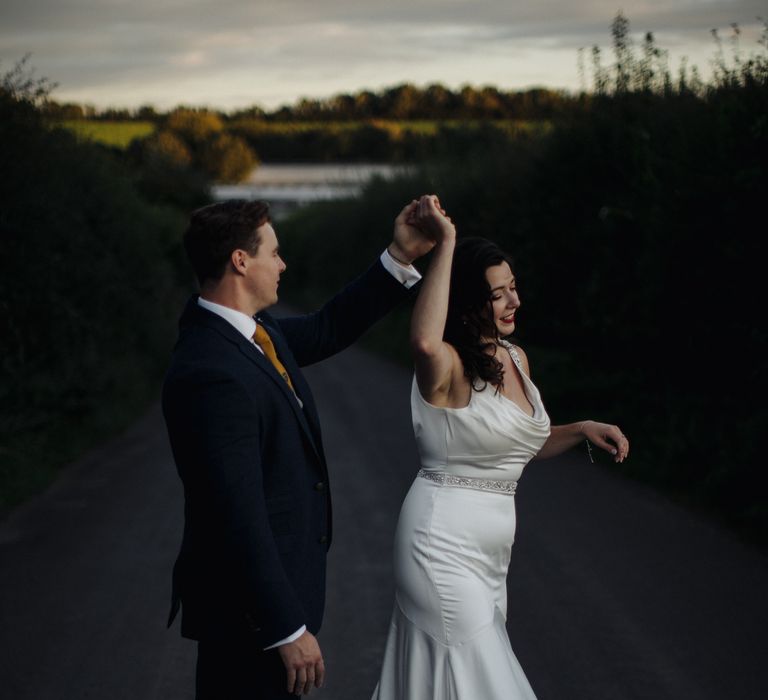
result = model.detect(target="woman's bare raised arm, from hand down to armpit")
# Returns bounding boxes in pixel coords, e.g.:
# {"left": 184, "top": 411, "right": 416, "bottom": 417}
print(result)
{"left": 411, "top": 195, "right": 461, "bottom": 405}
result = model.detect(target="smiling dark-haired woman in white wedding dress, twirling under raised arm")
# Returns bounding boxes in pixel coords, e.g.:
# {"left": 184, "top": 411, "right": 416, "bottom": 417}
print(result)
{"left": 373, "top": 196, "right": 629, "bottom": 700}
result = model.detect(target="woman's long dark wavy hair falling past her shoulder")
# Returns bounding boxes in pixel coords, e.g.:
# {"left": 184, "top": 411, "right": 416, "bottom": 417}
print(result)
{"left": 443, "top": 237, "right": 514, "bottom": 391}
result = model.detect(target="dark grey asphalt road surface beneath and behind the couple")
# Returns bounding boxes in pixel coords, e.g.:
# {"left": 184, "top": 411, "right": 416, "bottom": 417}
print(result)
{"left": 0, "top": 340, "right": 768, "bottom": 700}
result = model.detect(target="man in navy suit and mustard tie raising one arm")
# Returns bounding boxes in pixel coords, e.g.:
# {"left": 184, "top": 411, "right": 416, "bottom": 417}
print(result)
{"left": 163, "top": 200, "right": 433, "bottom": 700}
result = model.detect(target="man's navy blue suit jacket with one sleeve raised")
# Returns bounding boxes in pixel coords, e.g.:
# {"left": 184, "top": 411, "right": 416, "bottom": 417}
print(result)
{"left": 163, "top": 261, "right": 408, "bottom": 647}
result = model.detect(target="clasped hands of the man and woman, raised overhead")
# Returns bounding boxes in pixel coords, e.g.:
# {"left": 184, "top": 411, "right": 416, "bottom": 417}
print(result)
{"left": 387, "top": 194, "right": 456, "bottom": 265}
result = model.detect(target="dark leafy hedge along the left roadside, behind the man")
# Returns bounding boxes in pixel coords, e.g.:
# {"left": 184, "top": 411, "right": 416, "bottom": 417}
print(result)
{"left": 0, "top": 71, "right": 201, "bottom": 509}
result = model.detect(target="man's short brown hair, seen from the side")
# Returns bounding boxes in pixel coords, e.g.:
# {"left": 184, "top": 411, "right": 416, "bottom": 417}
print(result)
{"left": 184, "top": 199, "right": 271, "bottom": 286}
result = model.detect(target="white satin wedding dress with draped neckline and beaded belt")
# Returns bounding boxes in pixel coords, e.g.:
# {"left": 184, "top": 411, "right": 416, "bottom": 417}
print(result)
{"left": 373, "top": 343, "right": 549, "bottom": 700}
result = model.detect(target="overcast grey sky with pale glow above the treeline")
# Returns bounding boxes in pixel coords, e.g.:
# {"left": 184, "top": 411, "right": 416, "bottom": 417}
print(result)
{"left": 0, "top": 0, "right": 768, "bottom": 109}
